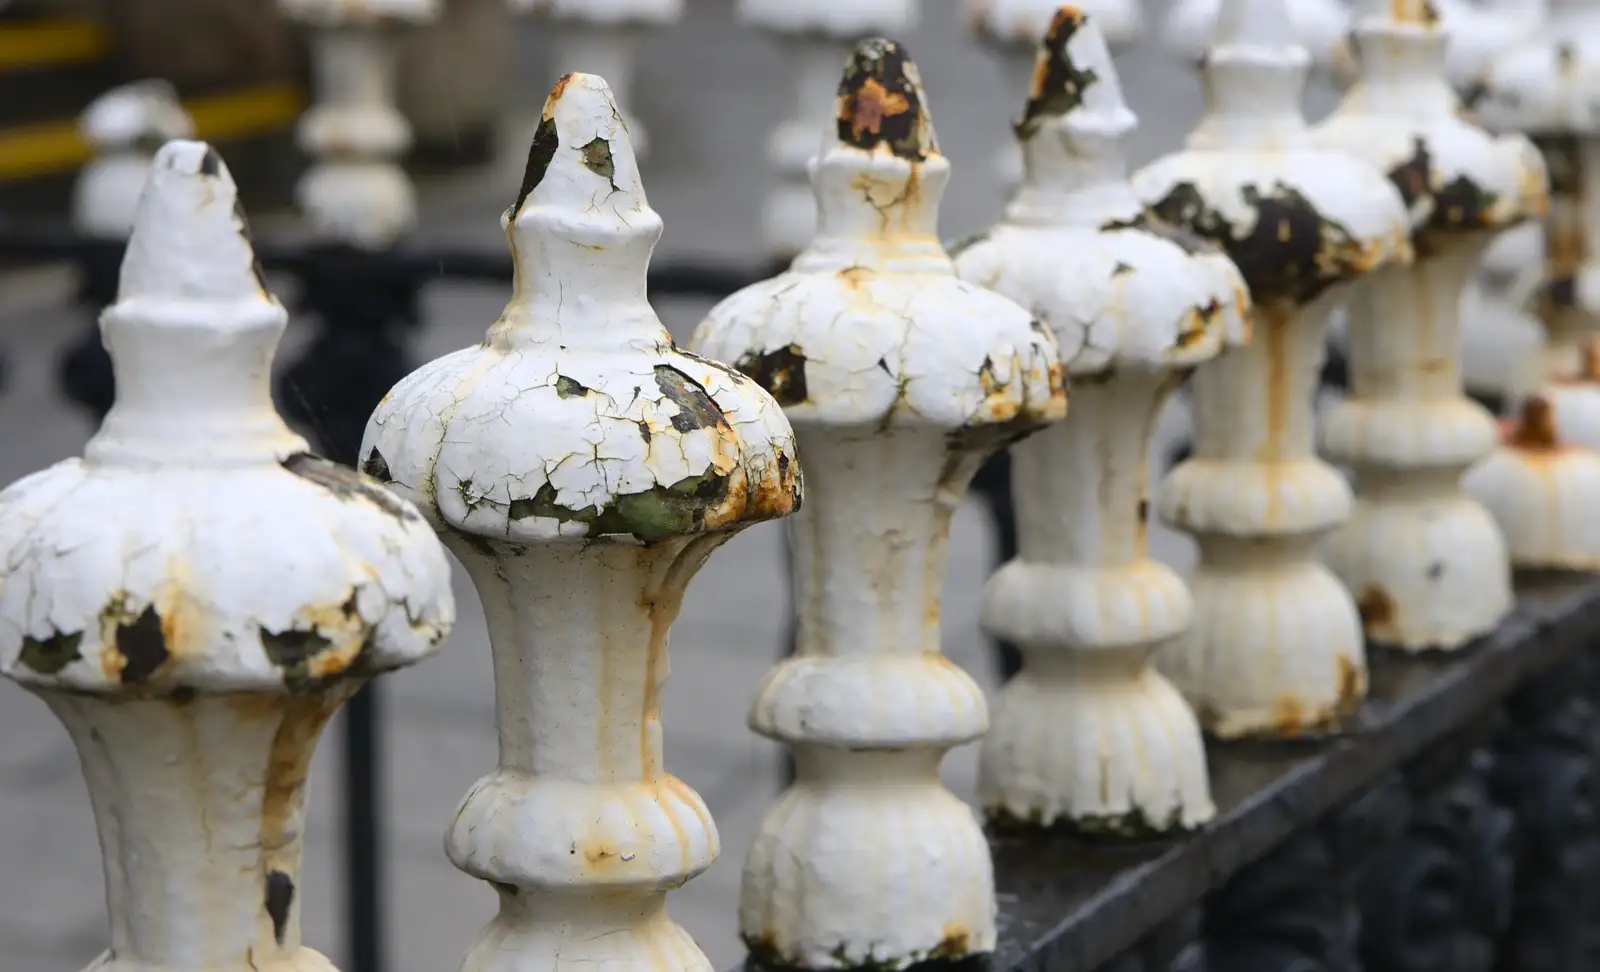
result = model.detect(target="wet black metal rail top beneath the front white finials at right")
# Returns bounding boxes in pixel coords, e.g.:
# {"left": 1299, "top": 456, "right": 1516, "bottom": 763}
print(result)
{"left": 966, "top": 574, "right": 1600, "bottom": 972}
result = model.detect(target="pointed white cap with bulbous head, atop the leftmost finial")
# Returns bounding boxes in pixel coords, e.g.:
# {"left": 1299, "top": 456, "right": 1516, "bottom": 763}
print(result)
{"left": 0, "top": 141, "right": 454, "bottom": 695}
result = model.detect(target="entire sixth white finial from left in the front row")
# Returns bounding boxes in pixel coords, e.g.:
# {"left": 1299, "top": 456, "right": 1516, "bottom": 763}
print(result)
{"left": 1317, "top": 0, "right": 1547, "bottom": 651}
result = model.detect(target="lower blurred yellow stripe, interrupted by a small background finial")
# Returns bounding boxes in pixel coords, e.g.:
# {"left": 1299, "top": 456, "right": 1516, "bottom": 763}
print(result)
{"left": 0, "top": 85, "right": 306, "bottom": 182}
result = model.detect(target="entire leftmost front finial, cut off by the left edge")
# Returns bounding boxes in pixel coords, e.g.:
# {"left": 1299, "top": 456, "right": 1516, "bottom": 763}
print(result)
{"left": 0, "top": 141, "right": 454, "bottom": 972}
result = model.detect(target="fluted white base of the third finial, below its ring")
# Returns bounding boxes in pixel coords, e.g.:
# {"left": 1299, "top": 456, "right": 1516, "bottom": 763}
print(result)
{"left": 739, "top": 745, "right": 995, "bottom": 972}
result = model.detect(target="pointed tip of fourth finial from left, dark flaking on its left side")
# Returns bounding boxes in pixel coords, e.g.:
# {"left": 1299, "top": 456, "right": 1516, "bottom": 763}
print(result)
{"left": 1014, "top": 6, "right": 1138, "bottom": 139}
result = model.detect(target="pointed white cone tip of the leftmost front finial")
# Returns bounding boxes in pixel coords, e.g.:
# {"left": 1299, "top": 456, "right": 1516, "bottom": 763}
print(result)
{"left": 117, "top": 139, "right": 270, "bottom": 302}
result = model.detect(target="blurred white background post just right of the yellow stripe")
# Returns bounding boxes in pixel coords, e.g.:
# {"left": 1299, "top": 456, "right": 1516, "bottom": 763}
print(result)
{"left": 278, "top": 0, "right": 438, "bottom": 249}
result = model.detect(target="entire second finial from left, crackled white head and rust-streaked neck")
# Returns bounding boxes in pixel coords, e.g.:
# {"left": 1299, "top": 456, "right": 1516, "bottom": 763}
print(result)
{"left": 362, "top": 74, "right": 800, "bottom": 972}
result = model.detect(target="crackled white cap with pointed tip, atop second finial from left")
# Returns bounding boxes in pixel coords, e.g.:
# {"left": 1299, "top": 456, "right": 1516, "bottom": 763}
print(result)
{"left": 362, "top": 74, "right": 800, "bottom": 544}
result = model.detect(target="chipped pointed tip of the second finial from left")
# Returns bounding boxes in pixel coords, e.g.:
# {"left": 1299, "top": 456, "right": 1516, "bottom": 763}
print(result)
{"left": 510, "top": 72, "right": 634, "bottom": 214}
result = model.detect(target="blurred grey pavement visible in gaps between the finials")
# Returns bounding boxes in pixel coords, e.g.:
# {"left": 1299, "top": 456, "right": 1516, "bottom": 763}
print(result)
{"left": 0, "top": 0, "right": 1350, "bottom": 972}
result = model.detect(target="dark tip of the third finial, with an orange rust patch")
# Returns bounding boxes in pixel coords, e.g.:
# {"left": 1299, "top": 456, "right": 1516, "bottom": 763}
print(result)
{"left": 837, "top": 37, "right": 939, "bottom": 161}
